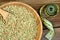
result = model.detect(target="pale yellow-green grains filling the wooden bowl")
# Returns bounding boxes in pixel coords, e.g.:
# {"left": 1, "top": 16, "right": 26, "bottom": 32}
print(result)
{"left": 0, "top": 5, "right": 37, "bottom": 40}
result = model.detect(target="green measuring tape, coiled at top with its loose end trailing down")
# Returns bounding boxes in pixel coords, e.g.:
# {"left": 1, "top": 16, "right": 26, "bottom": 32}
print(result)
{"left": 39, "top": 4, "right": 59, "bottom": 40}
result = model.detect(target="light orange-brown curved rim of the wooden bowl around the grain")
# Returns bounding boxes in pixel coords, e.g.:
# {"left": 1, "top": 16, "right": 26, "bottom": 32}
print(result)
{"left": 0, "top": 1, "right": 43, "bottom": 40}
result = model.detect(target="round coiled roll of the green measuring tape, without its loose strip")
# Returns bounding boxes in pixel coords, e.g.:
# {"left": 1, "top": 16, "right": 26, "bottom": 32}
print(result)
{"left": 45, "top": 4, "right": 58, "bottom": 16}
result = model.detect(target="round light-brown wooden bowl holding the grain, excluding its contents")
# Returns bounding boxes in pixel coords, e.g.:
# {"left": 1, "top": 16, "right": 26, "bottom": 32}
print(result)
{"left": 0, "top": 2, "right": 43, "bottom": 40}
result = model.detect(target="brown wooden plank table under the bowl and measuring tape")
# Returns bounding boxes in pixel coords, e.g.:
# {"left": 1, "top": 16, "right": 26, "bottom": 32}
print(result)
{"left": 0, "top": 0, "right": 60, "bottom": 40}
